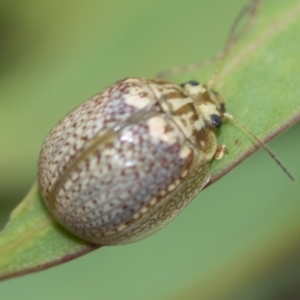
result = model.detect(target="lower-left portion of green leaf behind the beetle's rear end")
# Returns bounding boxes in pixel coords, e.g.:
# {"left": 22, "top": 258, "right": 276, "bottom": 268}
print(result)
{"left": 0, "top": 184, "right": 98, "bottom": 279}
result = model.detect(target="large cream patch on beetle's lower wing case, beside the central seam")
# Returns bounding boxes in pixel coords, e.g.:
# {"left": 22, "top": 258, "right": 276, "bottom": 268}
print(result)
{"left": 147, "top": 116, "right": 176, "bottom": 144}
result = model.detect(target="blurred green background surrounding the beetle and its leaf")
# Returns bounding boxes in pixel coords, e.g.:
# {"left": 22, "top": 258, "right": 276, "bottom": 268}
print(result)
{"left": 0, "top": 0, "right": 300, "bottom": 300}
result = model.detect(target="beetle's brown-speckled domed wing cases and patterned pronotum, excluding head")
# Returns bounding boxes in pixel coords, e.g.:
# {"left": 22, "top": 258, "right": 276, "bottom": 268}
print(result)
{"left": 39, "top": 78, "right": 225, "bottom": 245}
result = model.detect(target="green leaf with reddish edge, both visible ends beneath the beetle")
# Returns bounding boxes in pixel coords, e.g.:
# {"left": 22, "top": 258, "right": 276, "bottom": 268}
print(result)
{"left": 0, "top": 1, "right": 300, "bottom": 279}
